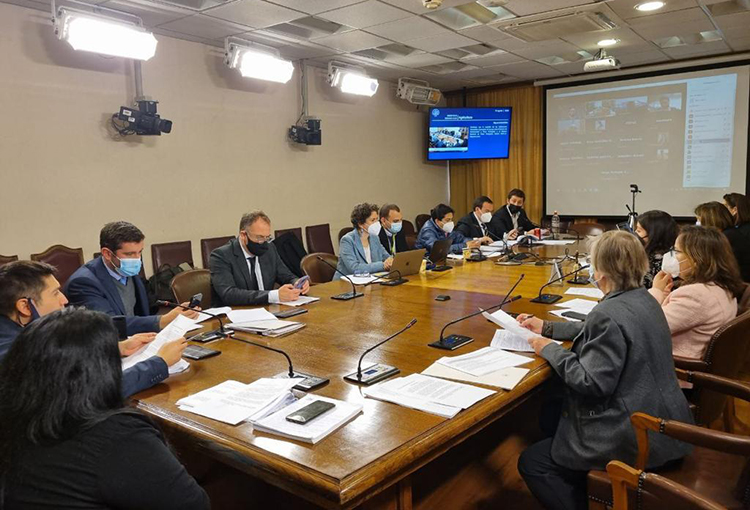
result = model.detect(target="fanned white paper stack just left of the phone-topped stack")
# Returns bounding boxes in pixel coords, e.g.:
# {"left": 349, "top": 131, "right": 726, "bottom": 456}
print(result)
{"left": 177, "top": 378, "right": 300, "bottom": 425}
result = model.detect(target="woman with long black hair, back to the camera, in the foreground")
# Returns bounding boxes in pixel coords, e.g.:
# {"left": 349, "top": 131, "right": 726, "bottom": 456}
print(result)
{"left": 0, "top": 308, "right": 210, "bottom": 510}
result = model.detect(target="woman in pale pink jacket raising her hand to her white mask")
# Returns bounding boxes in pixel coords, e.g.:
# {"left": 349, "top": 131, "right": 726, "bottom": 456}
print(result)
{"left": 649, "top": 226, "right": 745, "bottom": 359}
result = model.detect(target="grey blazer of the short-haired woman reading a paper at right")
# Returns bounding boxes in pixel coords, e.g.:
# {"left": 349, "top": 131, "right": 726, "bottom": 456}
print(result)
{"left": 541, "top": 287, "right": 693, "bottom": 471}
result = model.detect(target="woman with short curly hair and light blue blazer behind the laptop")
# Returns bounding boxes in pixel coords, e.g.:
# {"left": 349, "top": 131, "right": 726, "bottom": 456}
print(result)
{"left": 336, "top": 203, "right": 393, "bottom": 278}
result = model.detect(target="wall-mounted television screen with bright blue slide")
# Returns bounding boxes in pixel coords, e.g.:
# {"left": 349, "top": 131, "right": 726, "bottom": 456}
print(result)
{"left": 427, "top": 106, "right": 511, "bottom": 161}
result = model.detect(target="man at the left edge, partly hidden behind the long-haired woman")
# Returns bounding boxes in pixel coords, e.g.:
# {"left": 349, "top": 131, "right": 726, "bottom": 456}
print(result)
{"left": 0, "top": 260, "right": 187, "bottom": 397}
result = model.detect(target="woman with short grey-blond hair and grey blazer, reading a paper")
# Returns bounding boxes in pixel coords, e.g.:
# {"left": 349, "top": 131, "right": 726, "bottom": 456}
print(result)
{"left": 518, "top": 231, "right": 693, "bottom": 510}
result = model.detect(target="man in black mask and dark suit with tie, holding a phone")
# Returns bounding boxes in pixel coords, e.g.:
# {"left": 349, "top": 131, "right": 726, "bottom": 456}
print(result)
{"left": 209, "top": 211, "right": 310, "bottom": 306}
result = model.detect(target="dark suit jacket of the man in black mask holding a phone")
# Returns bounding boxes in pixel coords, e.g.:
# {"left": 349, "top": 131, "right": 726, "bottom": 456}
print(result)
{"left": 209, "top": 238, "right": 297, "bottom": 306}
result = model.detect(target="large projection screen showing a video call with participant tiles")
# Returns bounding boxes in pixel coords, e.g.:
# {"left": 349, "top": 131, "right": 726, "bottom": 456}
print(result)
{"left": 546, "top": 66, "right": 750, "bottom": 216}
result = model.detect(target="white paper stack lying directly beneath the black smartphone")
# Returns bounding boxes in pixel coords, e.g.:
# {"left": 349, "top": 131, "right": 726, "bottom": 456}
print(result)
{"left": 253, "top": 395, "right": 363, "bottom": 444}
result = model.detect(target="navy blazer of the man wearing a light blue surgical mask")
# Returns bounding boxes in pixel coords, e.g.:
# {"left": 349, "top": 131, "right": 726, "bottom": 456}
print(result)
{"left": 63, "top": 257, "right": 160, "bottom": 335}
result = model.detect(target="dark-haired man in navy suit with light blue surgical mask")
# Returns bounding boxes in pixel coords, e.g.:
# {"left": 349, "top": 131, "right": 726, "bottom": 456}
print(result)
{"left": 65, "top": 221, "right": 198, "bottom": 335}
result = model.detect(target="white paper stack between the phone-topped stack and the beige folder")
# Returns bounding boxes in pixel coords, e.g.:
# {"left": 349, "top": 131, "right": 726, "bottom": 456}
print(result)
{"left": 362, "top": 374, "right": 496, "bottom": 418}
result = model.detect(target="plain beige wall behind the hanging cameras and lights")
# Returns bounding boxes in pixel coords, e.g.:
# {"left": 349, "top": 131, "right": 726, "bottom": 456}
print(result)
{"left": 0, "top": 4, "right": 448, "bottom": 273}
